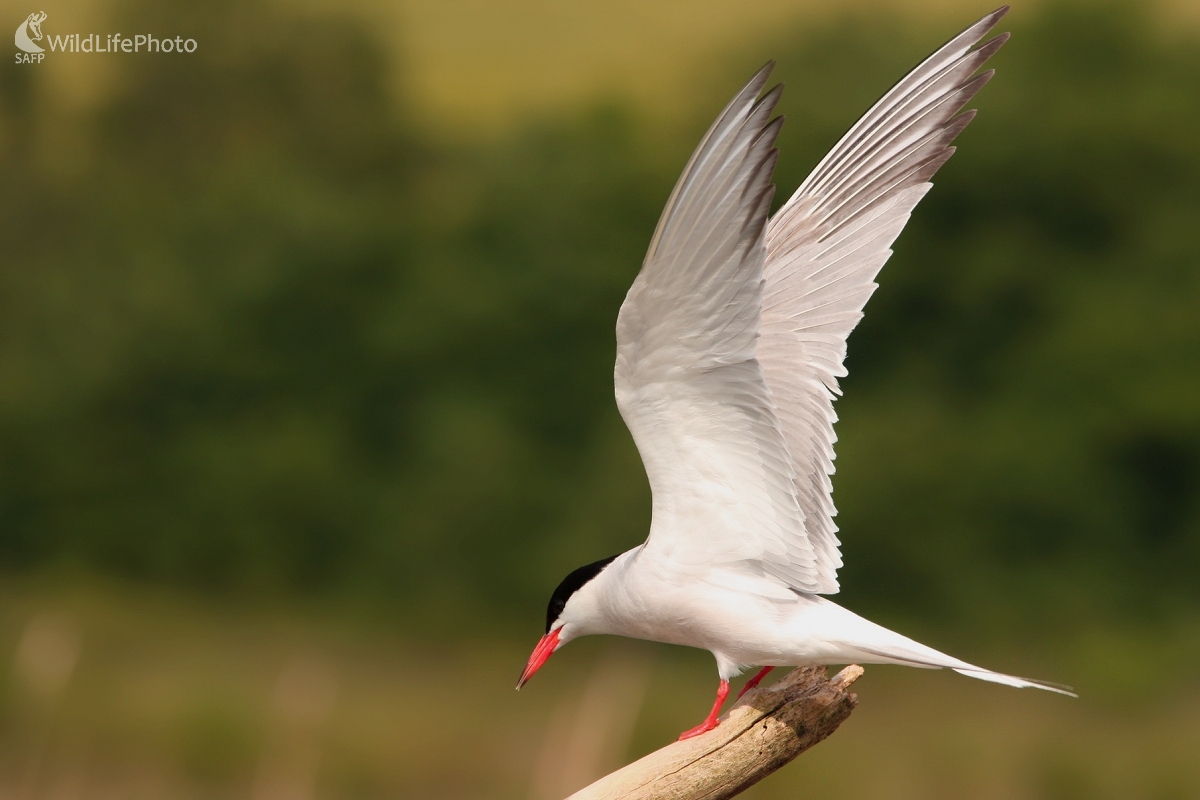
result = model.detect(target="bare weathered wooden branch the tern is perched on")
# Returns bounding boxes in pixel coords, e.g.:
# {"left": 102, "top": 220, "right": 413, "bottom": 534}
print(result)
{"left": 568, "top": 664, "right": 863, "bottom": 800}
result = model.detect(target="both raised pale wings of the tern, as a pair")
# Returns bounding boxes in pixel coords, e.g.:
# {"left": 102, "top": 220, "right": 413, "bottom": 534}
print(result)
{"left": 614, "top": 7, "right": 1007, "bottom": 594}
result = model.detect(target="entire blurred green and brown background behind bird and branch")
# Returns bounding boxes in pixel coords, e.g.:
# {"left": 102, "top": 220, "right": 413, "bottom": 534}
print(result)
{"left": 0, "top": 0, "right": 1200, "bottom": 800}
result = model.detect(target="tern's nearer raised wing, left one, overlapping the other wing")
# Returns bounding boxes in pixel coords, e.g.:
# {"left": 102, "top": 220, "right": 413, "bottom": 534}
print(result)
{"left": 616, "top": 65, "right": 818, "bottom": 591}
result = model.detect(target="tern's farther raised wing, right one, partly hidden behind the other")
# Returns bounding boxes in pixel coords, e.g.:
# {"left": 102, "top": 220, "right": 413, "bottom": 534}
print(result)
{"left": 756, "top": 6, "right": 1008, "bottom": 594}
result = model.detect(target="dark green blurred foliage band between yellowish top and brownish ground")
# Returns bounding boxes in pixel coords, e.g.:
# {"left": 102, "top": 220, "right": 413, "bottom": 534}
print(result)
{"left": 0, "top": 2, "right": 1200, "bottom": 632}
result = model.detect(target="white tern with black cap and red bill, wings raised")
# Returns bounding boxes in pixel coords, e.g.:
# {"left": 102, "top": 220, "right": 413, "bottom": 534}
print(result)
{"left": 517, "top": 6, "right": 1074, "bottom": 739}
